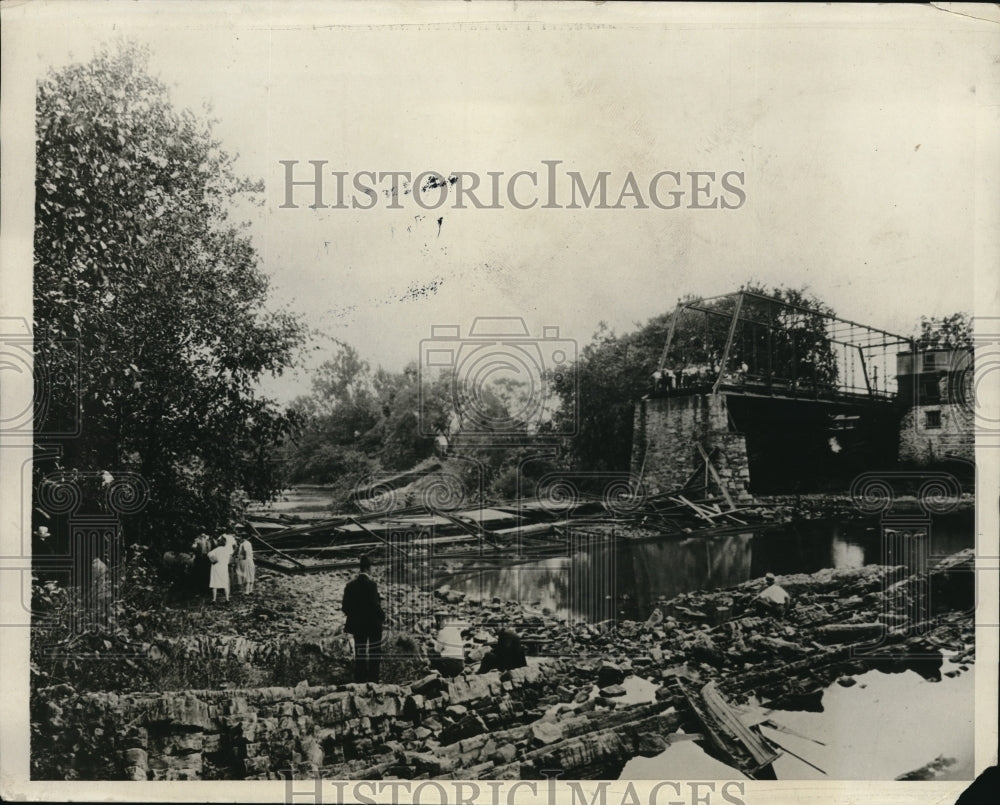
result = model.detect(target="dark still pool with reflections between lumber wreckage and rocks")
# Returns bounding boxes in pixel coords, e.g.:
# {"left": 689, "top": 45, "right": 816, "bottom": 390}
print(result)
{"left": 437, "top": 512, "right": 974, "bottom": 623}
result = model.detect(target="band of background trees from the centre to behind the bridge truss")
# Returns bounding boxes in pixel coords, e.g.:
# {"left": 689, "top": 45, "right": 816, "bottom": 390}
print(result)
{"left": 285, "top": 285, "right": 837, "bottom": 494}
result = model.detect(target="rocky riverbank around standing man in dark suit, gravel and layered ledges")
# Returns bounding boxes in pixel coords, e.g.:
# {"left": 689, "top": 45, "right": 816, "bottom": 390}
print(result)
{"left": 32, "top": 551, "right": 975, "bottom": 779}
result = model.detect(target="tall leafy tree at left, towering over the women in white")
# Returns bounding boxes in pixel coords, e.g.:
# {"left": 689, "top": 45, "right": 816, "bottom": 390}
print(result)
{"left": 34, "top": 44, "right": 304, "bottom": 541}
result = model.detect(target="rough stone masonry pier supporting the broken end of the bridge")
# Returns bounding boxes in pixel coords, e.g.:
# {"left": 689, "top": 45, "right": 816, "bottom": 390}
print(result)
{"left": 631, "top": 394, "right": 750, "bottom": 500}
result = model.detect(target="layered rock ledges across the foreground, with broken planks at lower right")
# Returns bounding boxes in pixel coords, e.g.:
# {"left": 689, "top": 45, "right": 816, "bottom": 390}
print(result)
{"left": 32, "top": 550, "right": 974, "bottom": 780}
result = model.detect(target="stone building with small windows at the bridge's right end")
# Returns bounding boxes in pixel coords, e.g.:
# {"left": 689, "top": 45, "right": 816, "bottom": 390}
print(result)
{"left": 896, "top": 347, "right": 976, "bottom": 465}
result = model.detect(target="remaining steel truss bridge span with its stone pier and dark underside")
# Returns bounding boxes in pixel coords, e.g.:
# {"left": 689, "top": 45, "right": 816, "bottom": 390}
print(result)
{"left": 631, "top": 290, "right": 914, "bottom": 500}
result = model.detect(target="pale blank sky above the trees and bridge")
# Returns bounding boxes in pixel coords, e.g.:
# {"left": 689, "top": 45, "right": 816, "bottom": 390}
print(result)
{"left": 3, "top": 3, "right": 997, "bottom": 400}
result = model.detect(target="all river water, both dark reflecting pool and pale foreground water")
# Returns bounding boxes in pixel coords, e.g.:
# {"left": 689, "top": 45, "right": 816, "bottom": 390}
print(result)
{"left": 438, "top": 511, "right": 975, "bottom": 780}
